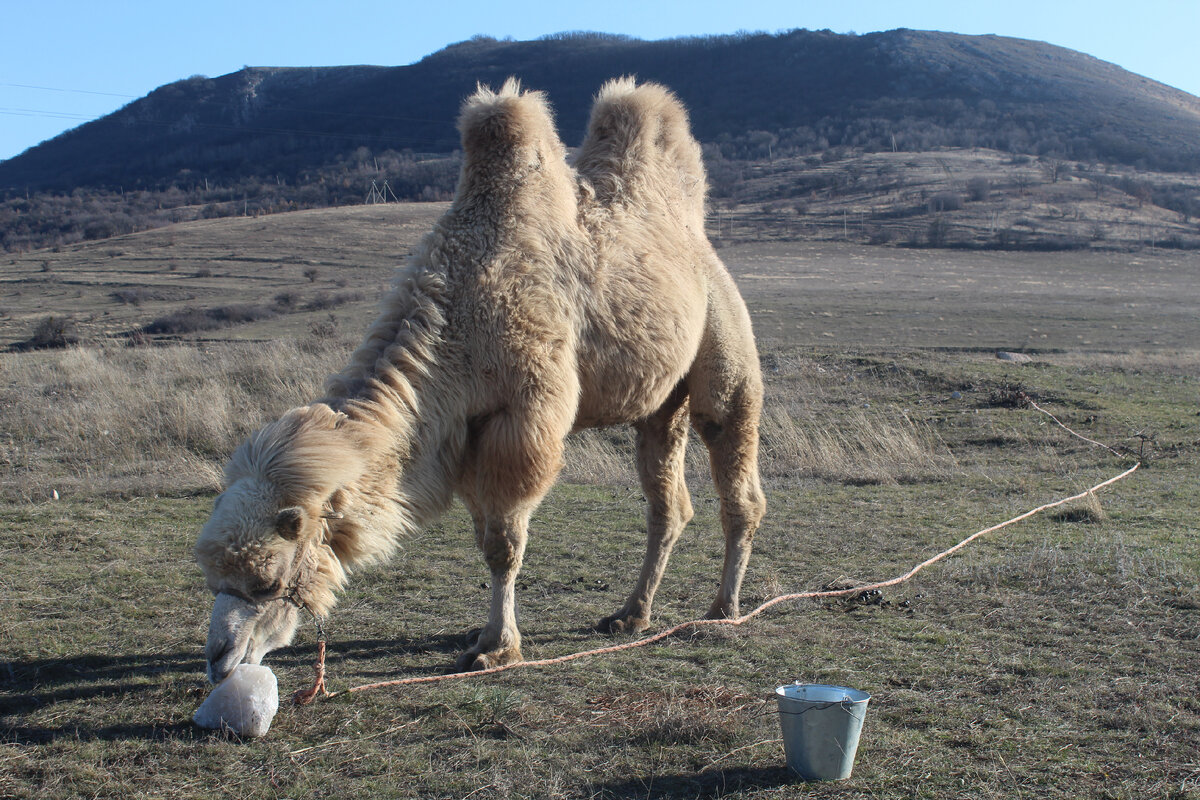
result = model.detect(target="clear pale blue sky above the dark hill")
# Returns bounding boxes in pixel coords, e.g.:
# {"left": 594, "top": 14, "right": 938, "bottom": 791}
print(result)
{"left": 0, "top": 0, "right": 1200, "bottom": 160}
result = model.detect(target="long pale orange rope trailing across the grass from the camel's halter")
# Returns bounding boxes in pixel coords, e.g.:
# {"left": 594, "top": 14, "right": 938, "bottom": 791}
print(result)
{"left": 292, "top": 393, "right": 1141, "bottom": 705}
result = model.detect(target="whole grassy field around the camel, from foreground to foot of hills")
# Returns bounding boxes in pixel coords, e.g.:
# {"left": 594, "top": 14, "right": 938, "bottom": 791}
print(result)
{"left": 0, "top": 207, "right": 1200, "bottom": 799}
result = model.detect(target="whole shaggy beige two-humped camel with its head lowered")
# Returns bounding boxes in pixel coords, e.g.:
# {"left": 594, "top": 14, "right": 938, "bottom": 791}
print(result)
{"left": 196, "top": 78, "right": 766, "bottom": 682}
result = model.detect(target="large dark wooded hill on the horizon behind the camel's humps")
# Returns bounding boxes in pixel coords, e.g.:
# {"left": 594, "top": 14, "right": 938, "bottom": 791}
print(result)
{"left": 7, "top": 30, "right": 1200, "bottom": 201}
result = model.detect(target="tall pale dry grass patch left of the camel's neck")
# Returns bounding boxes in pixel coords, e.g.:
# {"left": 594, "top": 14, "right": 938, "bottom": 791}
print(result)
{"left": 0, "top": 342, "right": 343, "bottom": 501}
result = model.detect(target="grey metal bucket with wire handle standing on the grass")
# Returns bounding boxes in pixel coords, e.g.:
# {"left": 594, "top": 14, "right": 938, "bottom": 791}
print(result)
{"left": 775, "top": 681, "right": 871, "bottom": 781}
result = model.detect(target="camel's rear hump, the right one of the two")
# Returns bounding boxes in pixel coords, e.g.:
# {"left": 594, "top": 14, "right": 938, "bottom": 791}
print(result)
{"left": 575, "top": 77, "right": 708, "bottom": 229}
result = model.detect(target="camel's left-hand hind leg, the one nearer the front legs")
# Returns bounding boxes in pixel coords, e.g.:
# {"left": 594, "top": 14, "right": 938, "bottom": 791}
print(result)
{"left": 596, "top": 385, "right": 692, "bottom": 633}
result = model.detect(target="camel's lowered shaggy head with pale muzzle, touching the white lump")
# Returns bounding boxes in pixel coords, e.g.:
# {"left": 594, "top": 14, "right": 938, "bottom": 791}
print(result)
{"left": 196, "top": 405, "right": 353, "bottom": 684}
